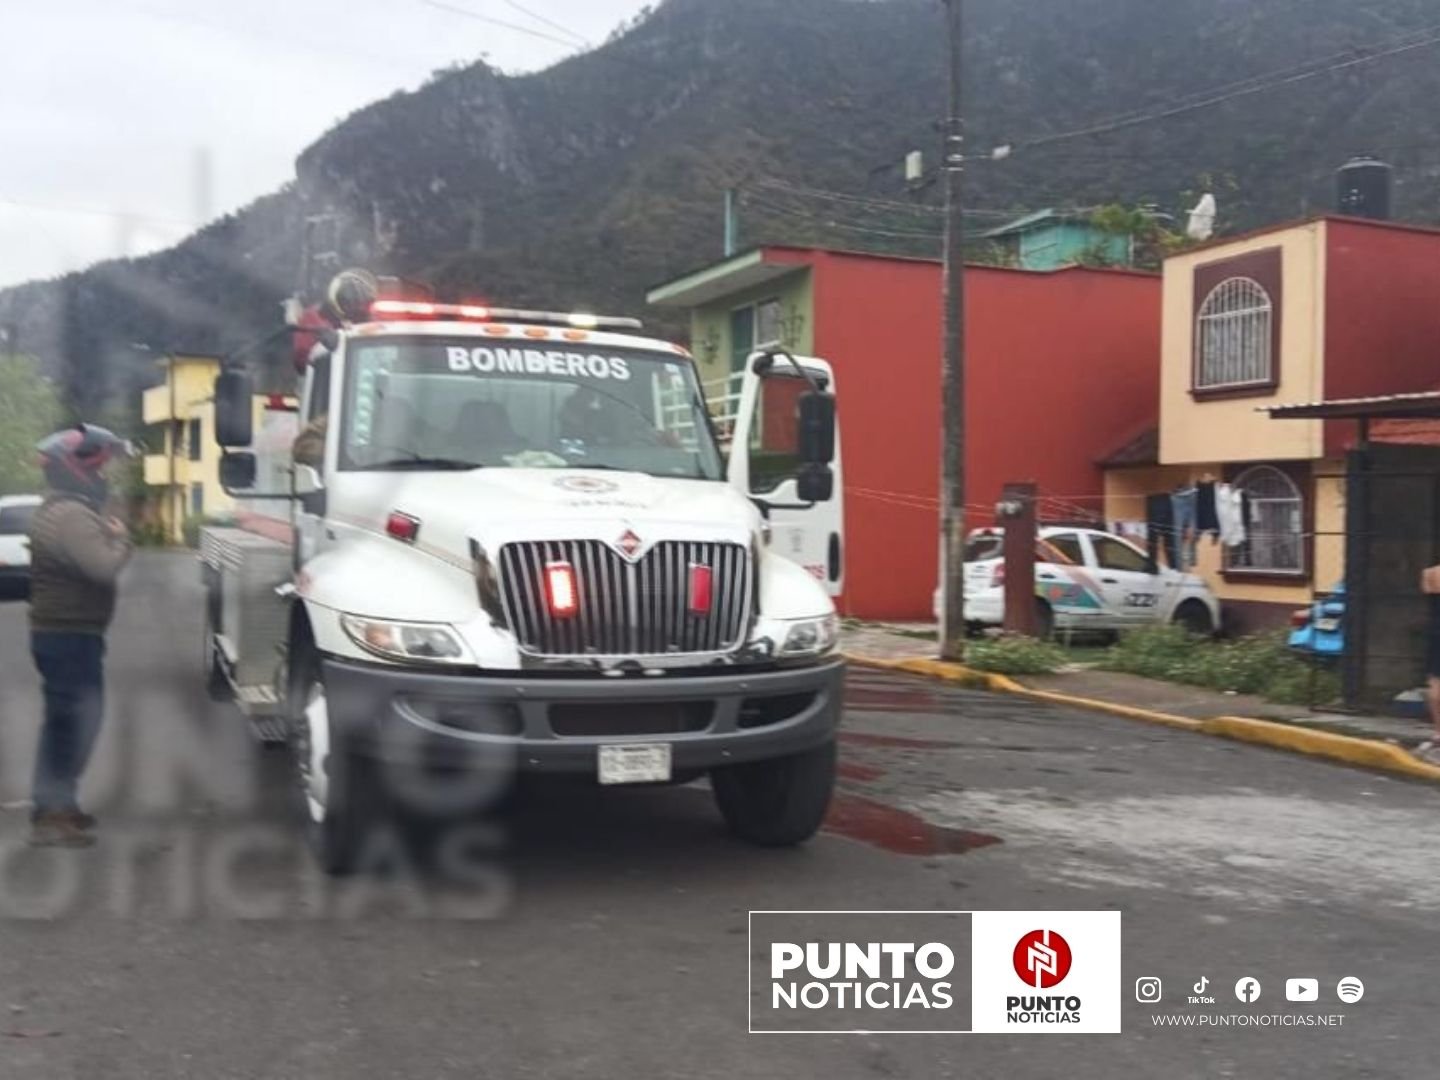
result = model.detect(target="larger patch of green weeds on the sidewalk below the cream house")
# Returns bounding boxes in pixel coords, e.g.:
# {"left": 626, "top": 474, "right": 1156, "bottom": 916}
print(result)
{"left": 1100, "top": 626, "right": 1339, "bottom": 704}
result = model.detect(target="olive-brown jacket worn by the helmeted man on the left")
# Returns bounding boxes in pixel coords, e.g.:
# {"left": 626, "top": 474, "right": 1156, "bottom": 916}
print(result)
{"left": 30, "top": 492, "right": 132, "bottom": 634}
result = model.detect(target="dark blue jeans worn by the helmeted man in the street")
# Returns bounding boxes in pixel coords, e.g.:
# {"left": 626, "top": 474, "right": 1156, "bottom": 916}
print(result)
{"left": 30, "top": 631, "right": 105, "bottom": 816}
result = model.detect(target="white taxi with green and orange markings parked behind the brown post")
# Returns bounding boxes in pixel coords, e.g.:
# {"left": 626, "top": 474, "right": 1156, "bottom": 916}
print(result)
{"left": 965, "top": 526, "right": 1220, "bottom": 636}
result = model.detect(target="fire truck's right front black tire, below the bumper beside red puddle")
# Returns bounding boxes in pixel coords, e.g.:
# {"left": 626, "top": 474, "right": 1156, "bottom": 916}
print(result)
{"left": 710, "top": 740, "right": 835, "bottom": 848}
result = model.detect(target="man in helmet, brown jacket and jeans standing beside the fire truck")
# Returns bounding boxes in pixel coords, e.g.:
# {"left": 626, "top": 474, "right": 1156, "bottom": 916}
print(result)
{"left": 30, "top": 423, "right": 132, "bottom": 848}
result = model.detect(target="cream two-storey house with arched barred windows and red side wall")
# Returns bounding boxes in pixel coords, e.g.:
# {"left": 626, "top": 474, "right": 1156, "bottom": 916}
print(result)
{"left": 1103, "top": 217, "right": 1440, "bottom": 631}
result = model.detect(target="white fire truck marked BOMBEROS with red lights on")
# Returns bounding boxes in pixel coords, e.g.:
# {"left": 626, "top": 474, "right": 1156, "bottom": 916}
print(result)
{"left": 202, "top": 275, "right": 844, "bottom": 873}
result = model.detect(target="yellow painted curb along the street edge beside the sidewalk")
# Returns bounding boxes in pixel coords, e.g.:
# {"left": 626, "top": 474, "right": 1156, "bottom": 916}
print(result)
{"left": 845, "top": 654, "right": 1440, "bottom": 782}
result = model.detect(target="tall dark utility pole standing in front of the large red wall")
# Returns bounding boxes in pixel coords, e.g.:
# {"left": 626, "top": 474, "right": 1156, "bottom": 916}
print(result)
{"left": 940, "top": 0, "right": 965, "bottom": 661}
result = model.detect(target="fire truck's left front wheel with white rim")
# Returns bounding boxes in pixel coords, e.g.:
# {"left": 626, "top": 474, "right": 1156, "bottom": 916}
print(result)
{"left": 289, "top": 645, "right": 382, "bottom": 877}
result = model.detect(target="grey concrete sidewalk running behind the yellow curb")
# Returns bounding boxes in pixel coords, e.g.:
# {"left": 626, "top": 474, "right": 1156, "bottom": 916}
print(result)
{"left": 840, "top": 624, "right": 1431, "bottom": 750}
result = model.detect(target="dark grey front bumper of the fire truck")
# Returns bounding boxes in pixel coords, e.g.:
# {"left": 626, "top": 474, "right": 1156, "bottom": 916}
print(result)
{"left": 324, "top": 658, "right": 845, "bottom": 776}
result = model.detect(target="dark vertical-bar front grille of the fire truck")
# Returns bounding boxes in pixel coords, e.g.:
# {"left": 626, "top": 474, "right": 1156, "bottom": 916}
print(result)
{"left": 500, "top": 540, "right": 755, "bottom": 657}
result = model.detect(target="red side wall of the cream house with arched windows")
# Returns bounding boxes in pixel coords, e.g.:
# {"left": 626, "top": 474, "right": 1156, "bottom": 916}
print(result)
{"left": 1325, "top": 217, "right": 1440, "bottom": 455}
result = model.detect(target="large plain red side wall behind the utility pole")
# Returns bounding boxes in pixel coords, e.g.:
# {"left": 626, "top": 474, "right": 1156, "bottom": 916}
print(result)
{"left": 809, "top": 252, "right": 1161, "bottom": 619}
